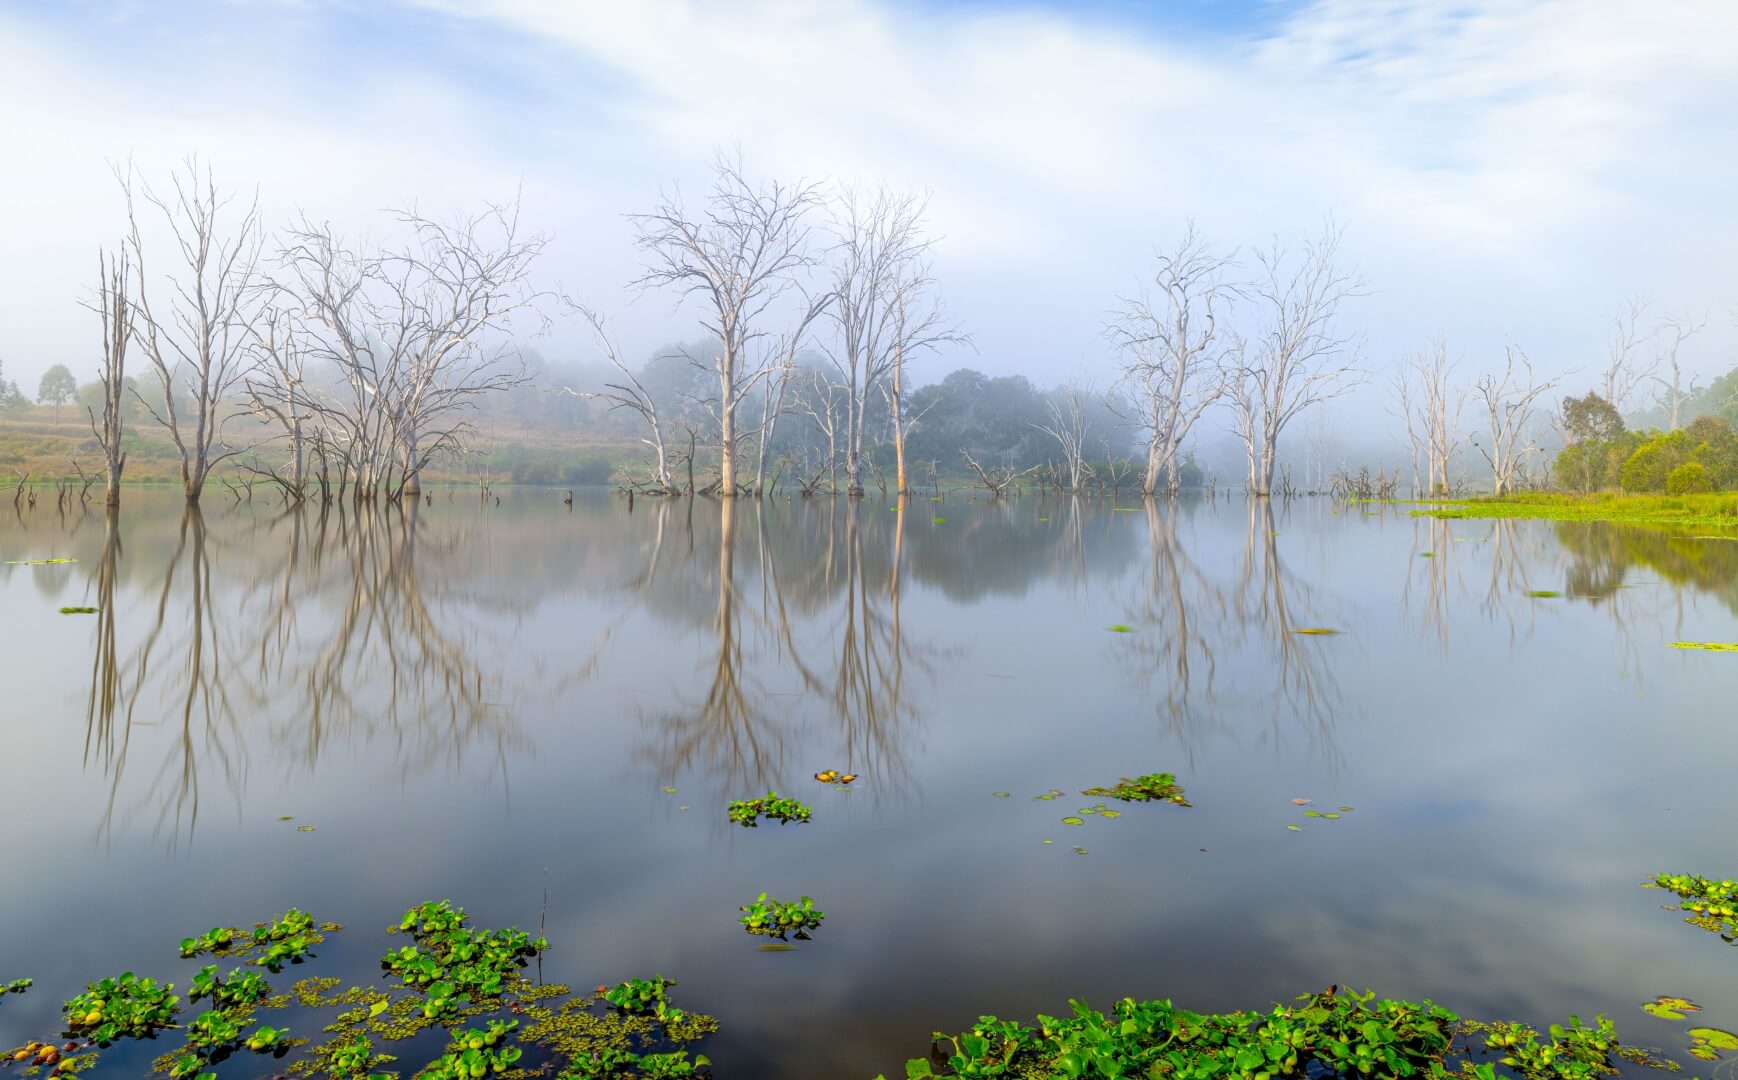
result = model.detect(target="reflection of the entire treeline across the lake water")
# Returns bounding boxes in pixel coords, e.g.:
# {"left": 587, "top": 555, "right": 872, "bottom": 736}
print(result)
{"left": 33, "top": 497, "right": 1738, "bottom": 843}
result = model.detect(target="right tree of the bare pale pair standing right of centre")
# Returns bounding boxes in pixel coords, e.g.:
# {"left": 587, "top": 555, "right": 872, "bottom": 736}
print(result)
{"left": 1231, "top": 221, "right": 1364, "bottom": 496}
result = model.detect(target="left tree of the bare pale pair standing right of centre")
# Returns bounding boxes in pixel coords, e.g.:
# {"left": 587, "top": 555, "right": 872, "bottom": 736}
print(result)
{"left": 1109, "top": 221, "right": 1239, "bottom": 496}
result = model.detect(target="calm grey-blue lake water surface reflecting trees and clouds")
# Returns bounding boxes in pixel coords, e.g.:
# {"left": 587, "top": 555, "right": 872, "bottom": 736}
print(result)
{"left": 0, "top": 490, "right": 1738, "bottom": 1078}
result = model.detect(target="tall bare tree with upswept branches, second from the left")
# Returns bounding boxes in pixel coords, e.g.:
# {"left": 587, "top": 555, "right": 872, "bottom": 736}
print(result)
{"left": 115, "top": 158, "right": 261, "bottom": 503}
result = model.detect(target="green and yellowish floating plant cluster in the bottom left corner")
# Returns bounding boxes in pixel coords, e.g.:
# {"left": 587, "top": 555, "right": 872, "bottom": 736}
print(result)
{"left": 0, "top": 901, "right": 718, "bottom": 1080}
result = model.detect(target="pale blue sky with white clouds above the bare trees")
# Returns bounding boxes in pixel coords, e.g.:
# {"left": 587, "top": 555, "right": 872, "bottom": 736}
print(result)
{"left": 0, "top": 0, "right": 1738, "bottom": 441}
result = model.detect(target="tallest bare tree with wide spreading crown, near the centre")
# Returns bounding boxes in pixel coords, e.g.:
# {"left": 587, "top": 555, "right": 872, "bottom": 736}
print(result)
{"left": 629, "top": 155, "right": 820, "bottom": 496}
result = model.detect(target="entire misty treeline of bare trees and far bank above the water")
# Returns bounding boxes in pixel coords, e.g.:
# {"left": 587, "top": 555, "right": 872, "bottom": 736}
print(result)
{"left": 13, "top": 145, "right": 1738, "bottom": 501}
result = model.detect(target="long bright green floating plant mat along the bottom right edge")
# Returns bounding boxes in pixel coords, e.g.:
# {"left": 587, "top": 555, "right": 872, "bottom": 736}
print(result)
{"left": 882, "top": 990, "right": 1668, "bottom": 1080}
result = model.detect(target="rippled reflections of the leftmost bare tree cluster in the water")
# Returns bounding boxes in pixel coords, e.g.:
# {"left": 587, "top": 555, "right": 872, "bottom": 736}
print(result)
{"left": 85, "top": 504, "right": 523, "bottom": 845}
